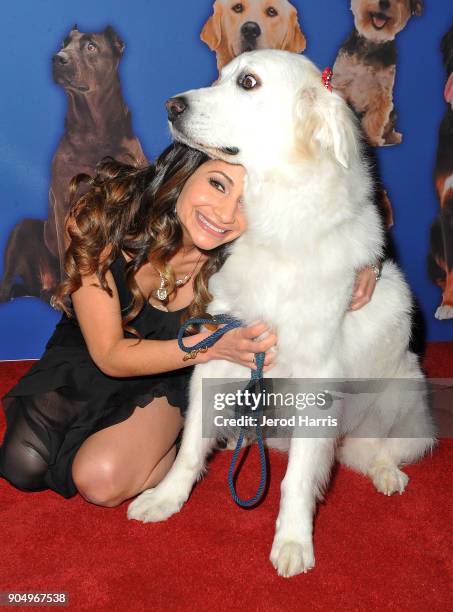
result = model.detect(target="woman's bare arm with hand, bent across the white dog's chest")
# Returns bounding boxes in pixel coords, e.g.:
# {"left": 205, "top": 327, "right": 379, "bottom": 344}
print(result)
{"left": 71, "top": 270, "right": 276, "bottom": 377}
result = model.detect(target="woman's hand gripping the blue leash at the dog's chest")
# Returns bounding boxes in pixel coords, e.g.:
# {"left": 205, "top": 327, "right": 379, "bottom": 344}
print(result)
{"left": 206, "top": 321, "right": 277, "bottom": 372}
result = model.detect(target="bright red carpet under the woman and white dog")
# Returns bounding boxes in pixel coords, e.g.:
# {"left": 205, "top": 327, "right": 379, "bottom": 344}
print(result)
{"left": 0, "top": 343, "right": 453, "bottom": 612}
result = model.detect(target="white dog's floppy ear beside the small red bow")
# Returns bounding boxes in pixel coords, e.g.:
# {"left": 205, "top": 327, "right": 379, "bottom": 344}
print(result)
{"left": 295, "top": 84, "right": 358, "bottom": 168}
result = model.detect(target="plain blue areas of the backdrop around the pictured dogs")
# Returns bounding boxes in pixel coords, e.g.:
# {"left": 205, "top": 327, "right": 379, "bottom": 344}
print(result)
{"left": 0, "top": 0, "right": 453, "bottom": 359}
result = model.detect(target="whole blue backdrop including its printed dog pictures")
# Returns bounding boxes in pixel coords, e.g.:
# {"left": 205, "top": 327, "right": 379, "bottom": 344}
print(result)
{"left": 0, "top": 0, "right": 453, "bottom": 359}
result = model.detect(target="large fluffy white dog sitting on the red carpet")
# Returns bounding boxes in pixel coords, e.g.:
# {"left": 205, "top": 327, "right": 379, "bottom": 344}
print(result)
{"left": 128, "top": 50, "right": 435, "bottom": 576}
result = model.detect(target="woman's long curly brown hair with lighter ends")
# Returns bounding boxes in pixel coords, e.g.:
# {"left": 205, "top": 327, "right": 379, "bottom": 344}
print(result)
{"left": 52, "top": 143, "right": 228, "bottom": 341}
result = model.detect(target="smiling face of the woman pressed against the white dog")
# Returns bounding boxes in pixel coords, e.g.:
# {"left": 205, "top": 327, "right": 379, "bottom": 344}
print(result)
{"left": 176, "top": 160, "right": 246, "bottom": 250}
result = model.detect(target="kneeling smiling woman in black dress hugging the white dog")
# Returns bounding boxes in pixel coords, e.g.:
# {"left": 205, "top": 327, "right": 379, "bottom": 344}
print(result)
{"left": 0, "top": 144, "right": 375, "bottom": 506}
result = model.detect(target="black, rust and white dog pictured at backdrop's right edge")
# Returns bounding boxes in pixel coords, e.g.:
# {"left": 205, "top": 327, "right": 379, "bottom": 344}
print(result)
{"left": 429, "top": 25, "right": 453, "bottom": 319}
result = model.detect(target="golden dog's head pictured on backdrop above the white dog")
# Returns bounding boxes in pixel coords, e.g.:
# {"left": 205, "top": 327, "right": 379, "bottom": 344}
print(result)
{"left": 200, "top": 0, "right": 306, "bottom": 71}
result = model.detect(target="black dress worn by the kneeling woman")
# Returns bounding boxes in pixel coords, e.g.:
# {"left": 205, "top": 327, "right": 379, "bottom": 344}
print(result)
{"left": 0, "top": 255, "right": 193, "bottom": 498}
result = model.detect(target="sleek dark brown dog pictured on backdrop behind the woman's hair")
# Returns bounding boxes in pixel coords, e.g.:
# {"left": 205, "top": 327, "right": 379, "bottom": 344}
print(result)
{"left": 0, "top": 26, "right": 147, "bottom": 302}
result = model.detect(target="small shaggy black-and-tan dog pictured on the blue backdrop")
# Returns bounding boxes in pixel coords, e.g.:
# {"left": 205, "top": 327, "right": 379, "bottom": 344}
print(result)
{"left": 332, "top": 0, "right": 423, "bottom": 146}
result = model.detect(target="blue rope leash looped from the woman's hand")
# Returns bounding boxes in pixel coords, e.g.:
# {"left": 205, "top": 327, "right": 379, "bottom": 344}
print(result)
{"left": 178, "top": 314, "right": 267, "bottom": 508}
